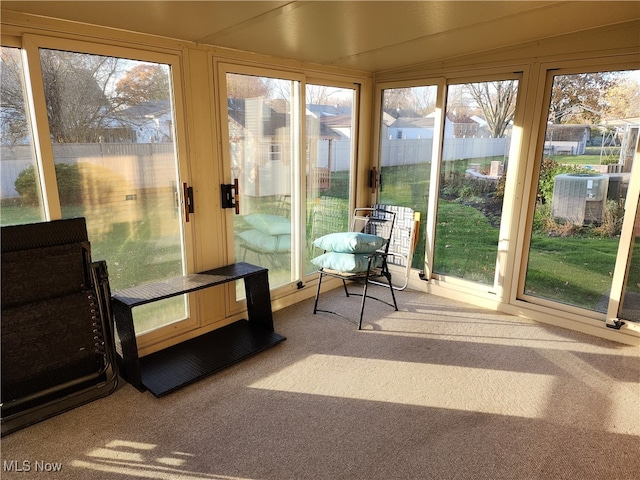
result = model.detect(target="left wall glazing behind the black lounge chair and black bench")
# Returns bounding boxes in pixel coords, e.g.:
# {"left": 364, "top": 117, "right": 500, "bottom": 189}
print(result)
{"left": 2, "top": 41, "right": 188, "bottom": 334}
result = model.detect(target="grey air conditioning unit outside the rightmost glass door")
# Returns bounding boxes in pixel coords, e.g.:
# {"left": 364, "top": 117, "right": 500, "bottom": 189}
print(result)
{"left": 551, "top": 173, "right": 609, "bottom": 225}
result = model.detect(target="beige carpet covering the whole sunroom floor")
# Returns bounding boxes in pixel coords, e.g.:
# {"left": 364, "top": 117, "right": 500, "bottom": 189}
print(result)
{"left": 1, "top": 290, "right": 640, "bottom": 480}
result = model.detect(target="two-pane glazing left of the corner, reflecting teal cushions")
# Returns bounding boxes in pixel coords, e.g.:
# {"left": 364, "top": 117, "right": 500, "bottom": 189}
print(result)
{"left": 220, "top": 65, "right": 356, "bottom": 288}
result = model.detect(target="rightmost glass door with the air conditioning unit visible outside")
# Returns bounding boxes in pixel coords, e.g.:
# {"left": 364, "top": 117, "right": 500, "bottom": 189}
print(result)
{"left": 524, "top": 71, "right": 640, "bottom": 318}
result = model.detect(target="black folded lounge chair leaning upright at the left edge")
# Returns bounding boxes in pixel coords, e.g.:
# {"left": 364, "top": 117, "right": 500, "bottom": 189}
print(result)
{"left": 0, "top": 218, "right": 117, "bottom": 435}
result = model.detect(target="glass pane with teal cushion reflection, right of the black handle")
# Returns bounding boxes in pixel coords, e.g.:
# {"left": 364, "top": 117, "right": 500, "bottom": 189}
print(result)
{"left": 226, "top": 73, "right": 300, "bottom": 293}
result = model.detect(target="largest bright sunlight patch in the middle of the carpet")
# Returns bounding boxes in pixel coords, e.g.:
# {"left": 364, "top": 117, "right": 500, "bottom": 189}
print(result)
{"left": 250, "top": 354, "right": 555, "bottom": 418}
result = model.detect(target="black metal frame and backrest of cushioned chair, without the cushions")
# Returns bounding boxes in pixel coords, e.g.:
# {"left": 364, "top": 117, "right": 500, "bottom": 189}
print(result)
{"left": 313, "top": 208, "right": 398, "bottom": 330}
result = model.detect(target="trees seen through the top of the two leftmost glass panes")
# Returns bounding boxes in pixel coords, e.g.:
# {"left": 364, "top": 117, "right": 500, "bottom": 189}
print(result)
{"left": 0, "top": 48, "right": 169, "bottom": 143}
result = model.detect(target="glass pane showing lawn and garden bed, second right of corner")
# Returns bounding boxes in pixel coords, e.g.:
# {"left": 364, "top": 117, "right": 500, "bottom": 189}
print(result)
{"left": 433, "top": 80, "right": 518, "bottom": 286}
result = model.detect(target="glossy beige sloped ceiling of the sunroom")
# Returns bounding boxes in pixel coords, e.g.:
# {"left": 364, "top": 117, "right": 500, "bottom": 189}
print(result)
{"left": 5, "top": 0, "right": 640, "bottom": 72}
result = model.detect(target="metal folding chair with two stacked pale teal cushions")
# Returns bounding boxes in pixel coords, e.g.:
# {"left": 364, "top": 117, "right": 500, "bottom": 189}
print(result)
{"left": 312, "top": 208, "right": 398, "bottom": 330}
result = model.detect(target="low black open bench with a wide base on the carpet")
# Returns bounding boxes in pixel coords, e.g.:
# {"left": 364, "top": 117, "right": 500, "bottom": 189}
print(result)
{"left": 112, "top": 262, "right": 286, "bottom": 397}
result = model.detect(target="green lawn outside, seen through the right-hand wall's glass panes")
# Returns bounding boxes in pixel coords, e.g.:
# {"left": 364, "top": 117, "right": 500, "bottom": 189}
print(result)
{"left": 382, "top": 155, "right": 640, "bottom": 309}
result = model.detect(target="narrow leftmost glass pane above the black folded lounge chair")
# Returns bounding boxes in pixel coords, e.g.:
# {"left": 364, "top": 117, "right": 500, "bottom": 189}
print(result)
{"left": 0, "top": 47, "right": 46, "bottom": 225}
